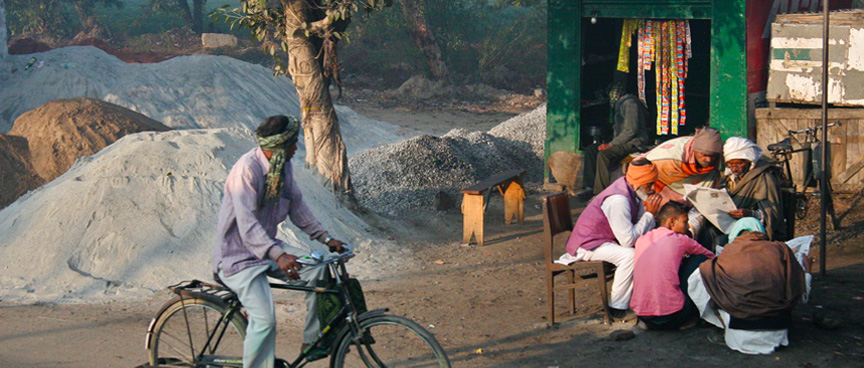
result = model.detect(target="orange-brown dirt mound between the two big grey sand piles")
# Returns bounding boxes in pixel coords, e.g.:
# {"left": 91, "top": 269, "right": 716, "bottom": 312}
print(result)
{"left": 9, "top": 97, "right": 170, "bottom": 181}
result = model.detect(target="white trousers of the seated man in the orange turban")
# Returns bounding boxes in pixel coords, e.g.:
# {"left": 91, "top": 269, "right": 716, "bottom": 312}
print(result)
{"left": 576, "top": 243, "right": 636, "bottom": 310}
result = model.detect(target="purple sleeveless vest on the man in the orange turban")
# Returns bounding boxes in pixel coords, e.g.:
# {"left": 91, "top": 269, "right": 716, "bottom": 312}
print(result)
{"left": 567, "top": 177, "right": 640, "bottom": 255}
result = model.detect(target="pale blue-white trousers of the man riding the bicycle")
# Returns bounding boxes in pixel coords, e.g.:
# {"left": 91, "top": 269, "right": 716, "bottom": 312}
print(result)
{"left": 219, "top": 261, "right": 327, "bottom": 368}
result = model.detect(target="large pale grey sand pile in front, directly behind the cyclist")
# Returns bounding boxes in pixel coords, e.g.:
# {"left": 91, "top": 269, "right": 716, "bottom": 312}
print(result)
{"left": 0, "top": 128, "right": 411, "bottom": 302}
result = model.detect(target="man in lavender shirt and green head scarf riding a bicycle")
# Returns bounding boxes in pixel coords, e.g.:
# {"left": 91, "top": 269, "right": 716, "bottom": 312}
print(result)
{"left": 213, "top": 115, "right": 345, "bottom": 368}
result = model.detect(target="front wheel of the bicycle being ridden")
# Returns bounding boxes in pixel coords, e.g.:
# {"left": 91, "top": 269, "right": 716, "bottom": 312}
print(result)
{"left": 330, "top": 315, "right": 450, "bottom": 368}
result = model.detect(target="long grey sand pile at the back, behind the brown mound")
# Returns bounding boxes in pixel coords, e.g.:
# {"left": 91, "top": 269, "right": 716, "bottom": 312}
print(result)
{"left": 0, "top": 46, "right": 300, "bottom": 133}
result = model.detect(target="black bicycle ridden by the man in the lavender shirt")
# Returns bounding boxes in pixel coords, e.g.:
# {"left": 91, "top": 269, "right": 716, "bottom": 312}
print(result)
{"left": 146, "top": 247, "right": 450, "bottom": 368}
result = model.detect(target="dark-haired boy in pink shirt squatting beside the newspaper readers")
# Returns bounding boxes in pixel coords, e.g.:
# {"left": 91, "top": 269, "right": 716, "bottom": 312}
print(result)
{"left": 630, "top": 201, "right": 714, "bottom": 330}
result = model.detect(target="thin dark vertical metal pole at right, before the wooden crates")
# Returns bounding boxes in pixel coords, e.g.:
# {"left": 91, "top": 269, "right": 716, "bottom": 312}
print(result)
{"left": 824, "top": 0, "right": 831, "bottom": 276}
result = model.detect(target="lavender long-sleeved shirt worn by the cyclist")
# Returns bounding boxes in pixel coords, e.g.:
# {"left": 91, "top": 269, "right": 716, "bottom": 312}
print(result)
{"left": 213, "top": 147, "right": 329, "bottom": 276}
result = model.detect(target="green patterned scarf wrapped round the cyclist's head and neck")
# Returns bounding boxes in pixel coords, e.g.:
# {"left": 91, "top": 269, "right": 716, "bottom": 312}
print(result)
{"left": 257, "top": 116, "right": 300, "bottom": 208}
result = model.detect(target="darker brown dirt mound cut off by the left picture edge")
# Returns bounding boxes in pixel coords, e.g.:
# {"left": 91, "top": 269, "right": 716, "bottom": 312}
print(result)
{"left": 0, "top": 134, "right": 45, "bottom": 208}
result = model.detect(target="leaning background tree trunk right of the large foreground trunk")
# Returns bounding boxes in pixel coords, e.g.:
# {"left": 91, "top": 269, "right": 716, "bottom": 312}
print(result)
{"left": 401, "top": 0, "right": 450, "bottom": 79}
